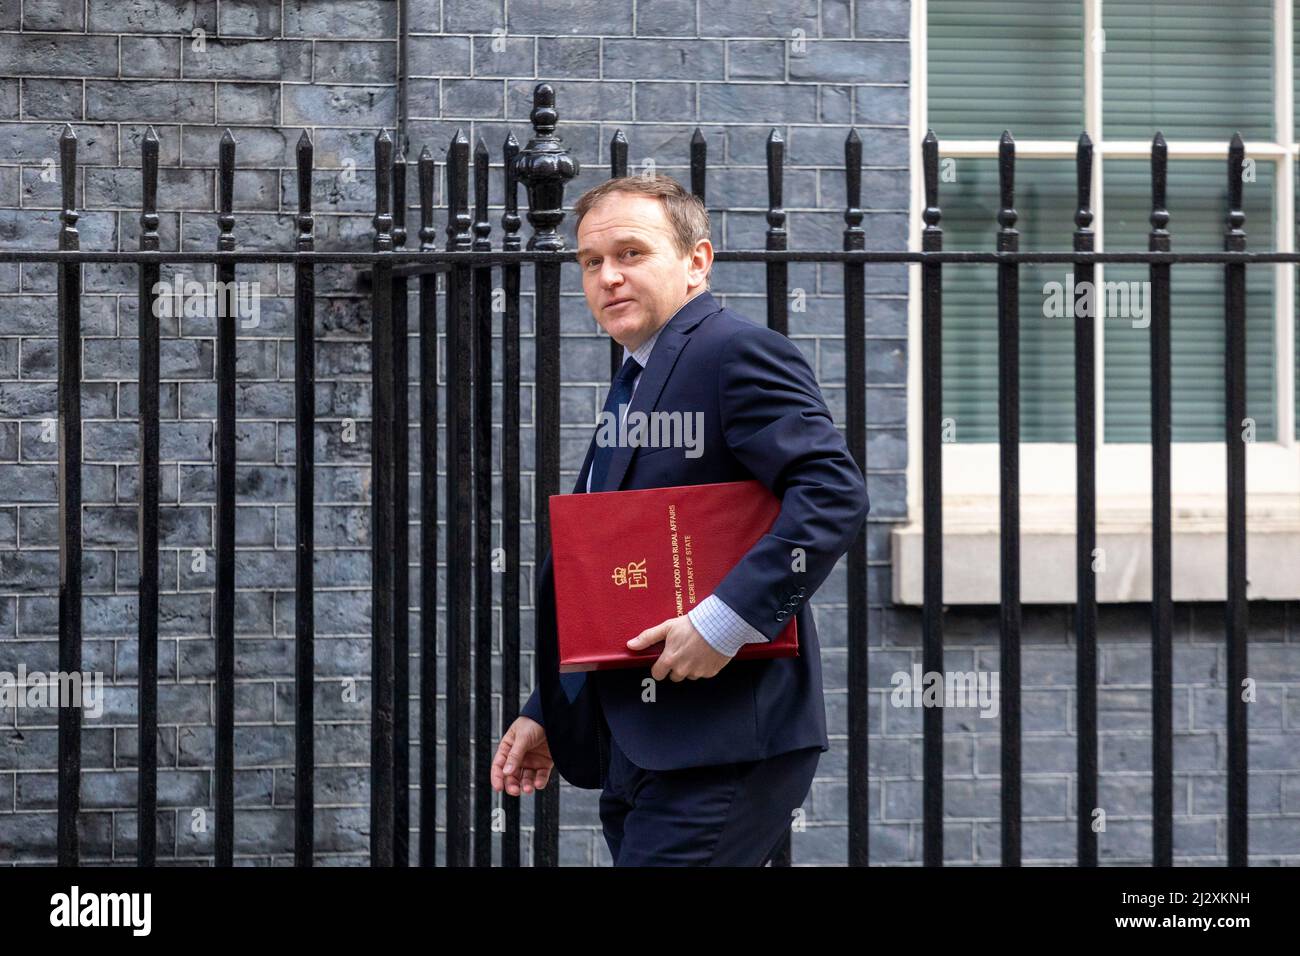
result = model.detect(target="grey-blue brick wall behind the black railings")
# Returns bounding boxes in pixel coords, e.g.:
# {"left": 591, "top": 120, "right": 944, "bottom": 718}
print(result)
{"left": 0, "top": 0, "right": 1300, "bottom": 865}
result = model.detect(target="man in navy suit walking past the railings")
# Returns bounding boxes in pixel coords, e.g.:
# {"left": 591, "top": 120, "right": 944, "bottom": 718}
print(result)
{"left": 491, "top": 177, "right": 868, "bottom": 866}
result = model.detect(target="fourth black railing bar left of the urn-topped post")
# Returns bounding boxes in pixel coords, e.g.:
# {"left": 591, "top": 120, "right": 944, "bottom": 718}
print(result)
{"left": 420, "top": 147, "right": 438, "bottom": 866}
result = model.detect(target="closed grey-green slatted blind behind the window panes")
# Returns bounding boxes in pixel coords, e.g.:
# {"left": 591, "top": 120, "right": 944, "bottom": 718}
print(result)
{"left": 927, "top": 0, "right": 1284, "bottom": 442}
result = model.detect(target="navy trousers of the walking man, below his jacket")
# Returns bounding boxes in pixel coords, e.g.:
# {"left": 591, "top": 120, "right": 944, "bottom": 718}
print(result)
{"left": 599, "top": 715, "right": 822, "bottom": 866}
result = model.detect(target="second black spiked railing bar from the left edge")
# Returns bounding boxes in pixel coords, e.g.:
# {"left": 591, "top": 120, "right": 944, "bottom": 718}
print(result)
{"left": 135, "top": 126, "right": 160, "bottom": 866}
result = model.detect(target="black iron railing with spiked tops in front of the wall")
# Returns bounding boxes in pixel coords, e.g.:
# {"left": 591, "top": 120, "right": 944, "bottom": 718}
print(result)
{"left": 0, "top": 83, "right": 1258, "bottom": 866}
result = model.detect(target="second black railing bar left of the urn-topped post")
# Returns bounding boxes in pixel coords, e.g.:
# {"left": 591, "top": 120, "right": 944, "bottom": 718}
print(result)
{"left": 473, "top": 137, "right": 494, "bottom": 866}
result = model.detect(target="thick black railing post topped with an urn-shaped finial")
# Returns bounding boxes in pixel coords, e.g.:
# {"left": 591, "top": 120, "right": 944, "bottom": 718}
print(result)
{"left": 515, "top": 83, "right": 580, "bottom": 866}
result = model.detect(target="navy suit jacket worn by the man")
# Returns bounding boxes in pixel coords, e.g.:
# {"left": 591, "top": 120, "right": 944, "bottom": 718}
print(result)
{"left": 521, "top": 291, "right": 868, "bottom": 788}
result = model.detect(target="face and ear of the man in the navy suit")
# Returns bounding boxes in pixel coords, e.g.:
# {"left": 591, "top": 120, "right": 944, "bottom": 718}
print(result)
{"left": 577, "top": 193, "right": 714, "bottom": 349}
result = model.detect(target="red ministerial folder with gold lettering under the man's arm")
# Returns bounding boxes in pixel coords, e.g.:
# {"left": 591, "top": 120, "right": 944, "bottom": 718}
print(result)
{"left": 550, "top": 480, "right": 798, "bottom": 674}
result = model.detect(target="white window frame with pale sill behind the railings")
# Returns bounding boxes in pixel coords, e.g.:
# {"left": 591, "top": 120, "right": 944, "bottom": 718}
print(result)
{"left": 892, "top": 0, "right": 1300, "bottom": 604}
